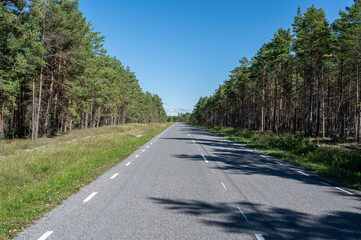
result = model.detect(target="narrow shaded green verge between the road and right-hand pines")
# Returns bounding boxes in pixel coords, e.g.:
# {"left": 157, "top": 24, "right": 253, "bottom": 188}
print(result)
{"left": 194, "top": 126, "right": 361, "bottom": 190}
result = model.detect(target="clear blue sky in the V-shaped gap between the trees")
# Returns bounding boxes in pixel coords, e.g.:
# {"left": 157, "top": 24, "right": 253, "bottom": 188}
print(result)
{"left": 79, "top": 0, "right": 353, "bottom": 114}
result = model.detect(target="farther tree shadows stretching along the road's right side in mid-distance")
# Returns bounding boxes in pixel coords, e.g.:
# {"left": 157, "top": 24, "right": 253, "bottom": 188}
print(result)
{"left": 164, "top": 127, "right": 361, "bottom": 197}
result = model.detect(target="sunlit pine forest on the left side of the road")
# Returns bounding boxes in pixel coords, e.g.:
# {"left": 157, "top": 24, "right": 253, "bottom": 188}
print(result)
{"left": 0, "top": 0, "right": 166, "bottom": 139}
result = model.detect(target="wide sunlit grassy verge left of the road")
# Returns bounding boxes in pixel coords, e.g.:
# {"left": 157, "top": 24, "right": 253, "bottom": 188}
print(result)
{"left": 0, "top": 123, "right": 171, "bottom": 239}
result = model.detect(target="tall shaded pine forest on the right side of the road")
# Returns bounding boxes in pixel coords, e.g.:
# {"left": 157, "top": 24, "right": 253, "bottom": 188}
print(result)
{"left": 191, "top": 0, "right": 361, "bottom": 142}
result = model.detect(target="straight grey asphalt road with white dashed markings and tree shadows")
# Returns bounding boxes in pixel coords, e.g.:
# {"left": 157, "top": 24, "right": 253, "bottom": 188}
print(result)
{"left": 18, "top": 123, "right": 361, "bottom": 240}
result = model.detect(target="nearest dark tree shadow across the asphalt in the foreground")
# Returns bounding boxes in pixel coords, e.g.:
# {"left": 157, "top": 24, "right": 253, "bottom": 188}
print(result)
{"left": 148, "top": 197, "right": 361, "bottom": 240}
